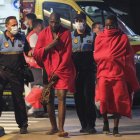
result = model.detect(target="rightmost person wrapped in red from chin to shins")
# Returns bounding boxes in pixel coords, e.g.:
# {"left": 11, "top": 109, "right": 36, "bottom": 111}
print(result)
{"left": 94, "top": 15, "right": 140, "bottom": 136}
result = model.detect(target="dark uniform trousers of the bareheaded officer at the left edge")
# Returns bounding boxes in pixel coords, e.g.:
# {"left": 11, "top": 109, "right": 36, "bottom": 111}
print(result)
{"left": 0, "top": 69, "right": 28, "bottom": 128}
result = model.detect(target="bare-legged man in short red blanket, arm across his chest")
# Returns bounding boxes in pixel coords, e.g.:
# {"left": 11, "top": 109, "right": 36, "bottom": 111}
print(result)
{"left": 34, "top": 13, "right": 75, "bottom": 136}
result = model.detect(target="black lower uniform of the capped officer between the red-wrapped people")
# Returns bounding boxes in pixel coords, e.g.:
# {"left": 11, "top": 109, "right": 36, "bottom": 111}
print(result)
{"left": 73, "top": 53, "right": 96, "bottom": 129}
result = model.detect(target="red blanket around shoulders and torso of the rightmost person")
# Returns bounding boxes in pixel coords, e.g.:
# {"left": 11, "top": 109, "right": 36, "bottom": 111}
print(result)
{"left": 94, "top": 29, "right": 139, "bottom": 91}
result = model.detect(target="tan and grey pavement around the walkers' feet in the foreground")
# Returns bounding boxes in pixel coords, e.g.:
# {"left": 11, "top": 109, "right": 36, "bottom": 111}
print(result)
{"left": 0, "top": 107, "right": 140, "bottom": 140}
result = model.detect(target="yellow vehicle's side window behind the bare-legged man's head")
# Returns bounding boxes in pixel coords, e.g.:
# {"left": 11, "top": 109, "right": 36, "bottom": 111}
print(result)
{"left": 43, "top": 2, "right": 76, "bottom": 29}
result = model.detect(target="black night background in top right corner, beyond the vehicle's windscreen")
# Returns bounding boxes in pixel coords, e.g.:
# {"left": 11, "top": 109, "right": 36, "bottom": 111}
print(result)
{"left": 104, "top": 0, "right": 140, "bottom": 35}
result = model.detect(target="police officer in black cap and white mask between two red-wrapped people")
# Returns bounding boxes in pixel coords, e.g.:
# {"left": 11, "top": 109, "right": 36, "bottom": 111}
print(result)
{"left": 72, "top": 12, "right": 96, "bottom": 134}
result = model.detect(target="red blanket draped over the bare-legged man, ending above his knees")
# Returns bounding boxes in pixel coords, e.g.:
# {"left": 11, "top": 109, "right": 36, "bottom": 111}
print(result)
{"left": 34, "top": 27, "right": 75, "bottom": 92}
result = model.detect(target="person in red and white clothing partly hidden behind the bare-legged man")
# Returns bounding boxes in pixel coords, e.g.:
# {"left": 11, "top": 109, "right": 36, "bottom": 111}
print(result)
{"left": 24, "top": 18, "right": 46, "bottom": 118}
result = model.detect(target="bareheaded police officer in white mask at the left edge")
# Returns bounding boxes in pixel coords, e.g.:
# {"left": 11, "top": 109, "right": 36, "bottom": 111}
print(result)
{"left": 0, "top": 16, "right": 30, "bottom": 134}
